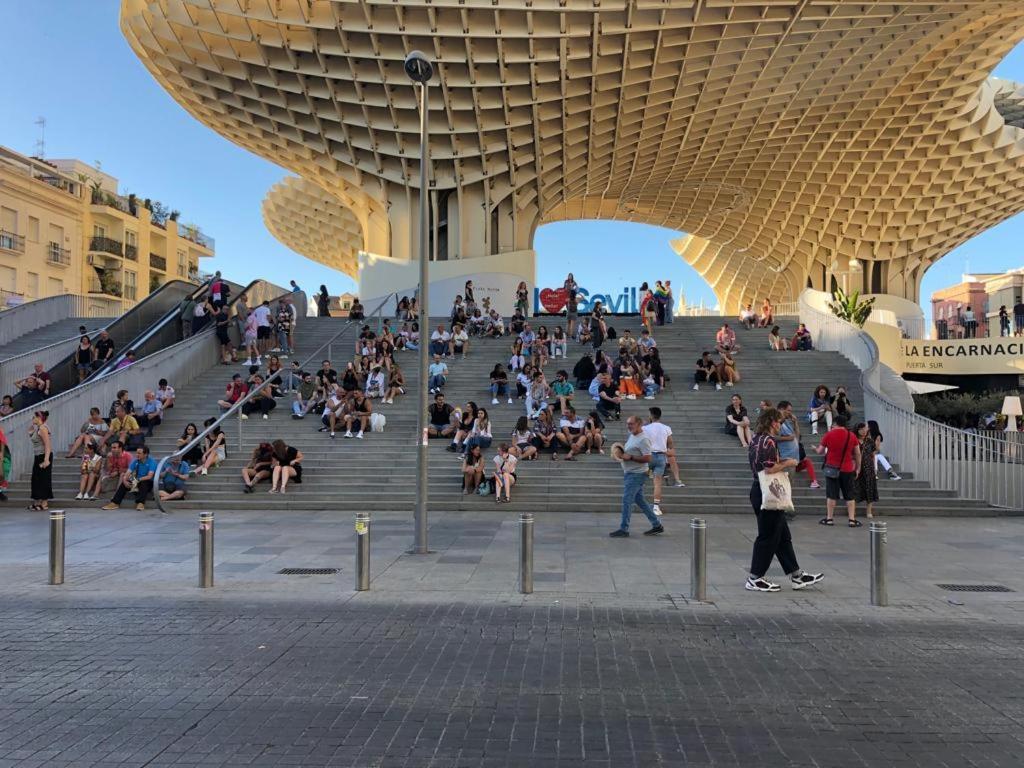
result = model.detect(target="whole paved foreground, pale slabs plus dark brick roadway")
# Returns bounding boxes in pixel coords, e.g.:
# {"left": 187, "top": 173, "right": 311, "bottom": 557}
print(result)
{"left": 0, "top": 505, "right": 1024, "bottom": 768}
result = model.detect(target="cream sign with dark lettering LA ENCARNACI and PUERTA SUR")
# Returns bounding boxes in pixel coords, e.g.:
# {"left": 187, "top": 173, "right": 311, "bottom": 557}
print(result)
{"left": 903, "top": 339, "right": 1024, "bottom": 374}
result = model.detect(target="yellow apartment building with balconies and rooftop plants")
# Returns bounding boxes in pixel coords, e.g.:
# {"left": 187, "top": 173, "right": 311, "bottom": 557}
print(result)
{"left": 0, "top": 146, "right": 215, "bottom": 309}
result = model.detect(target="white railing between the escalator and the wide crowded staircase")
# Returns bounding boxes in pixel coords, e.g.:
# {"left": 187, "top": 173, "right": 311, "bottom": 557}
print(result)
{"left": 0, "top": 328, "right": 220, "bottom": 480}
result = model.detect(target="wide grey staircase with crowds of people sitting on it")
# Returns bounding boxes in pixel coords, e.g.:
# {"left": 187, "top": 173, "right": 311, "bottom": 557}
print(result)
{"left": 11, "top": 317, "right": 998, "bottom": 515}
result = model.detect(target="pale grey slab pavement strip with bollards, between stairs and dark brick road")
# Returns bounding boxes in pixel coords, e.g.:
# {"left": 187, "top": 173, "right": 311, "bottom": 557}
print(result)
{"left": 0, "top": 509, "right": 1024, "bottom": 625}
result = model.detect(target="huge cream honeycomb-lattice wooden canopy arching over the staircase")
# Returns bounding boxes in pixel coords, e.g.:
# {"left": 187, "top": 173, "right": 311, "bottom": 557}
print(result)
{"left": 121, "top": 0, "right": 1024, "bottom": 308}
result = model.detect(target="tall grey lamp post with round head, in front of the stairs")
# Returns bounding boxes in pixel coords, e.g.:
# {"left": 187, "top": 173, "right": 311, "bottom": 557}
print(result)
{"left": 406, "top": 50, "right": 434, "bottom": 555}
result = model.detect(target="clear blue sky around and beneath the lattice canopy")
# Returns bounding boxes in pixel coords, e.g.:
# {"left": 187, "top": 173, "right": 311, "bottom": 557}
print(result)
{"left": 0, "top": 0, "right": 1024, "bottom": 317}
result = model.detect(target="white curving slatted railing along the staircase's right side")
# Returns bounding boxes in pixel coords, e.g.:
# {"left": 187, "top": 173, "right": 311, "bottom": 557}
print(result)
{"left": 800, "top": 289, "right": 1024, "bottom": 511}
